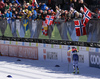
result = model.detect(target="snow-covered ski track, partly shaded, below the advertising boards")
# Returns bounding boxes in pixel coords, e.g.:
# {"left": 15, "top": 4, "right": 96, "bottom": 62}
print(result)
{"left": 0, "top": 56, "right": 100, "bottom": 79}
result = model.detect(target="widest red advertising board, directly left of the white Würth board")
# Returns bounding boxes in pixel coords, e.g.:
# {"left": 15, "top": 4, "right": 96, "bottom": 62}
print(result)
{"left": 18, "top": 46, "right": 38, "bottom": 60}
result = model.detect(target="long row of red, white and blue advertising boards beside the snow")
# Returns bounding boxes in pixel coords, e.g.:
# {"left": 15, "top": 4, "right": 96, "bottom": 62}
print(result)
{"left": 0, "top": 41, "right": 90, "bottom": 67}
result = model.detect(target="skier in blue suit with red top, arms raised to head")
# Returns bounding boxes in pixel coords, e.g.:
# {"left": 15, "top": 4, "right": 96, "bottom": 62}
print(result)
{"left": 68, "top": 47, "right": 79, "bottom": 74}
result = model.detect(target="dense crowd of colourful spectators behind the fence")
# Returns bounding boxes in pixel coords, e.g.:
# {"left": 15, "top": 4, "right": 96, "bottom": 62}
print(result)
{"left": 0, "top": 0, "right": 100, "bottom": 20}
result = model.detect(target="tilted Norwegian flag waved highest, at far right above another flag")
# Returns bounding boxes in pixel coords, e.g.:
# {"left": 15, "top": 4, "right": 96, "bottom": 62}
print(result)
{"left": 83, "top": 6, "right": 92, "bottom": 26}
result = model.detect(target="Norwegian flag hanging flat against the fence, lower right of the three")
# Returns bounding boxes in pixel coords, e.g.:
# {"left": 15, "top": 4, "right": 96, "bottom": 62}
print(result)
{"left": 74, "top": 20, "right": 86, "bottom": 36}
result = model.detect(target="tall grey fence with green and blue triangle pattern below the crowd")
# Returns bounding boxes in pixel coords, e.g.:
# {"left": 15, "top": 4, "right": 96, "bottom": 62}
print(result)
{"left": 0, "top": 19, "right": 100, "bottom": 47}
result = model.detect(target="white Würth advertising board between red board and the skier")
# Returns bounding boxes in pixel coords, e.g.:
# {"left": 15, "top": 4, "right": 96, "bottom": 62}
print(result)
{"left": 38, "top": 47, "right": 61, "bottom": 61}
